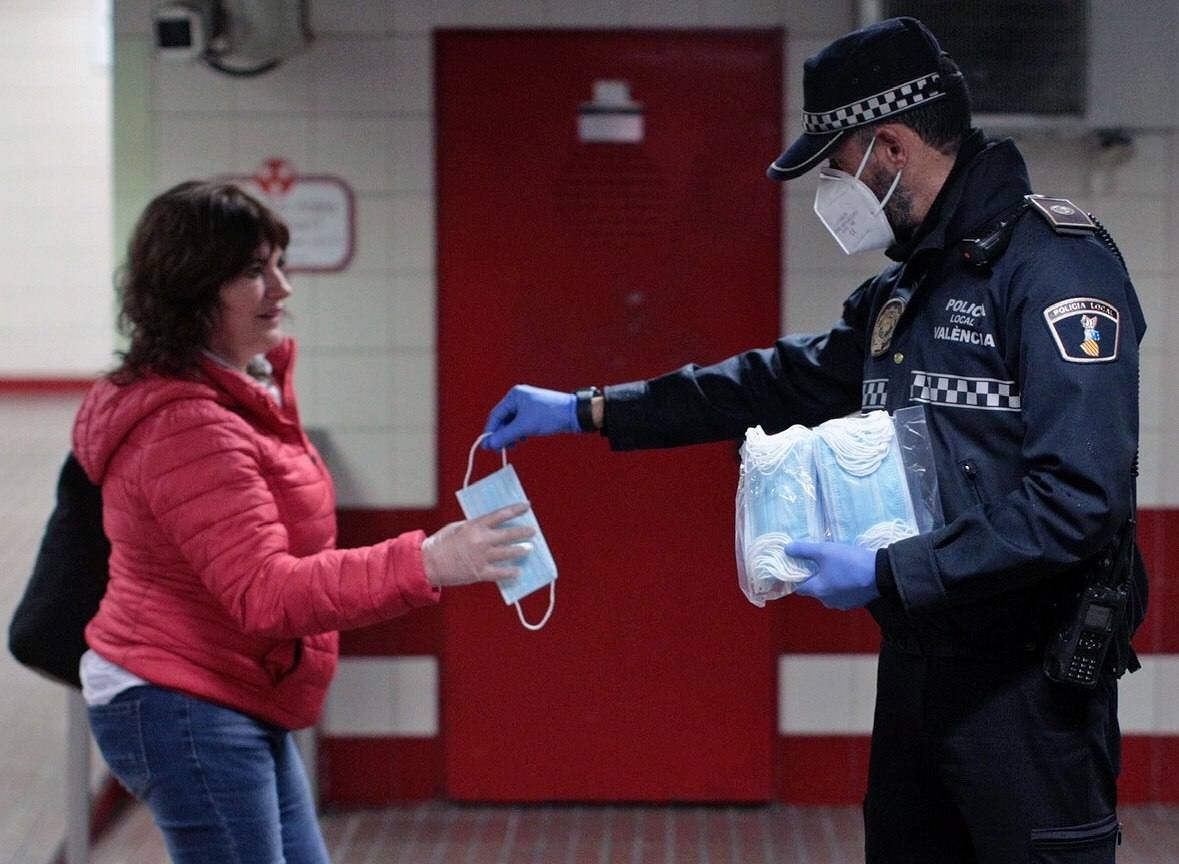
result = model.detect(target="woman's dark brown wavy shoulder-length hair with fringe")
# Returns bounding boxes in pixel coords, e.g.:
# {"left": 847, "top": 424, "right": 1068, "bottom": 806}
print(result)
{"left": 113, "top": 180, "right": 290, "bottom": 383}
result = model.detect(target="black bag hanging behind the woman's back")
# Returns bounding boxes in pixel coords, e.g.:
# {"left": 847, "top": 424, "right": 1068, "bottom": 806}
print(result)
{"left": 8, "top": 453, "right": 111, "bottom": 688}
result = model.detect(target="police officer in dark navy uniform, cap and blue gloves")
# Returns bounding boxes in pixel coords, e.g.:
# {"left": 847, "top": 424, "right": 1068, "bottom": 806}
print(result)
{"left": 485, "top": 18, "right": 1146, "bottom": 864}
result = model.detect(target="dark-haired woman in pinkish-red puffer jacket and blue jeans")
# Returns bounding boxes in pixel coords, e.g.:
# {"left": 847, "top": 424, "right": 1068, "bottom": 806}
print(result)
{"left": 73, "top": 183, "right": 532, "bottom": 864}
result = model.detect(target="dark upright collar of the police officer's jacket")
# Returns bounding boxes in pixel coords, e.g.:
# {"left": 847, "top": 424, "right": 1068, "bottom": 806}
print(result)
{"left": 884, "top": 130, "right": 1032, "bottom": 262}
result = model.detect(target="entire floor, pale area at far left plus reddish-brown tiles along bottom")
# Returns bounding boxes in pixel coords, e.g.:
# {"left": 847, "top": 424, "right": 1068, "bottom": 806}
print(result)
{"left": 0, "top": 395, "right": 1179, "bottom": 864}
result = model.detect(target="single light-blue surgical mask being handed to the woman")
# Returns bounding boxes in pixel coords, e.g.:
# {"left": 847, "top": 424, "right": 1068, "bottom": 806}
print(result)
{"left": 455, "top": 435, "right": 556, "bottom": 631}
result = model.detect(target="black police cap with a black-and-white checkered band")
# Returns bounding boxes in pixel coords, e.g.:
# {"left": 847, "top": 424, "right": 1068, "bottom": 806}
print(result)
{"left": 765, "top": 18, "right": 946, "bottom": 180}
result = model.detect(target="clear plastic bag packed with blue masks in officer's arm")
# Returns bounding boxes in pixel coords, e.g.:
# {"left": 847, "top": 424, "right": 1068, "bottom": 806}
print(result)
{"left": 736, "top": 405, "right": 942, "bottom": 606}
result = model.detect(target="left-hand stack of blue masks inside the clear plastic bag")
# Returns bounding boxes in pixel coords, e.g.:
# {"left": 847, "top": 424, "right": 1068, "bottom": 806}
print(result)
{"left": 737, "top": 426, "right": 824, "bottom": 598}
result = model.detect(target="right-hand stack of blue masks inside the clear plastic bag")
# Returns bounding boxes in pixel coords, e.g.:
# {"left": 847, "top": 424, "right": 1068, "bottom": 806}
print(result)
{"left": 815, "top": 411, "right": 917, "bottom": 549}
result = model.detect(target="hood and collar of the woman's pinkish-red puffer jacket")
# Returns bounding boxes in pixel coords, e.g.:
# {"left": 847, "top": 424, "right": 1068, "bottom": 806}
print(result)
{"left": 73, "top": 339, "right": 297, "bottom": 486}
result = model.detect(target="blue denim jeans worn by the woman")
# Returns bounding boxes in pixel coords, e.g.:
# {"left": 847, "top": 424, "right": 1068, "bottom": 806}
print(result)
{"left": 90, "top": 685, "right": 329, "bottom": 864}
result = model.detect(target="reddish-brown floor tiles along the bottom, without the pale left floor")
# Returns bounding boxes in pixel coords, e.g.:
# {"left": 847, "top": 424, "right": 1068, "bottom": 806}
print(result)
{"left": 93, "top": 804, "right": 1179, "bottom": 864}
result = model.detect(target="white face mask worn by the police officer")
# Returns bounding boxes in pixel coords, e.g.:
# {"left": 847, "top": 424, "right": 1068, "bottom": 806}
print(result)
{"left": 815, "top": 136, "right": 901, "bottom": 255}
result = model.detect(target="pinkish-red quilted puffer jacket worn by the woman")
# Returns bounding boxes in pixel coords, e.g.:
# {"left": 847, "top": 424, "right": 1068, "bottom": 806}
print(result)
{"left": 73, "top": 339, "right": 439, "bottom": 728}
